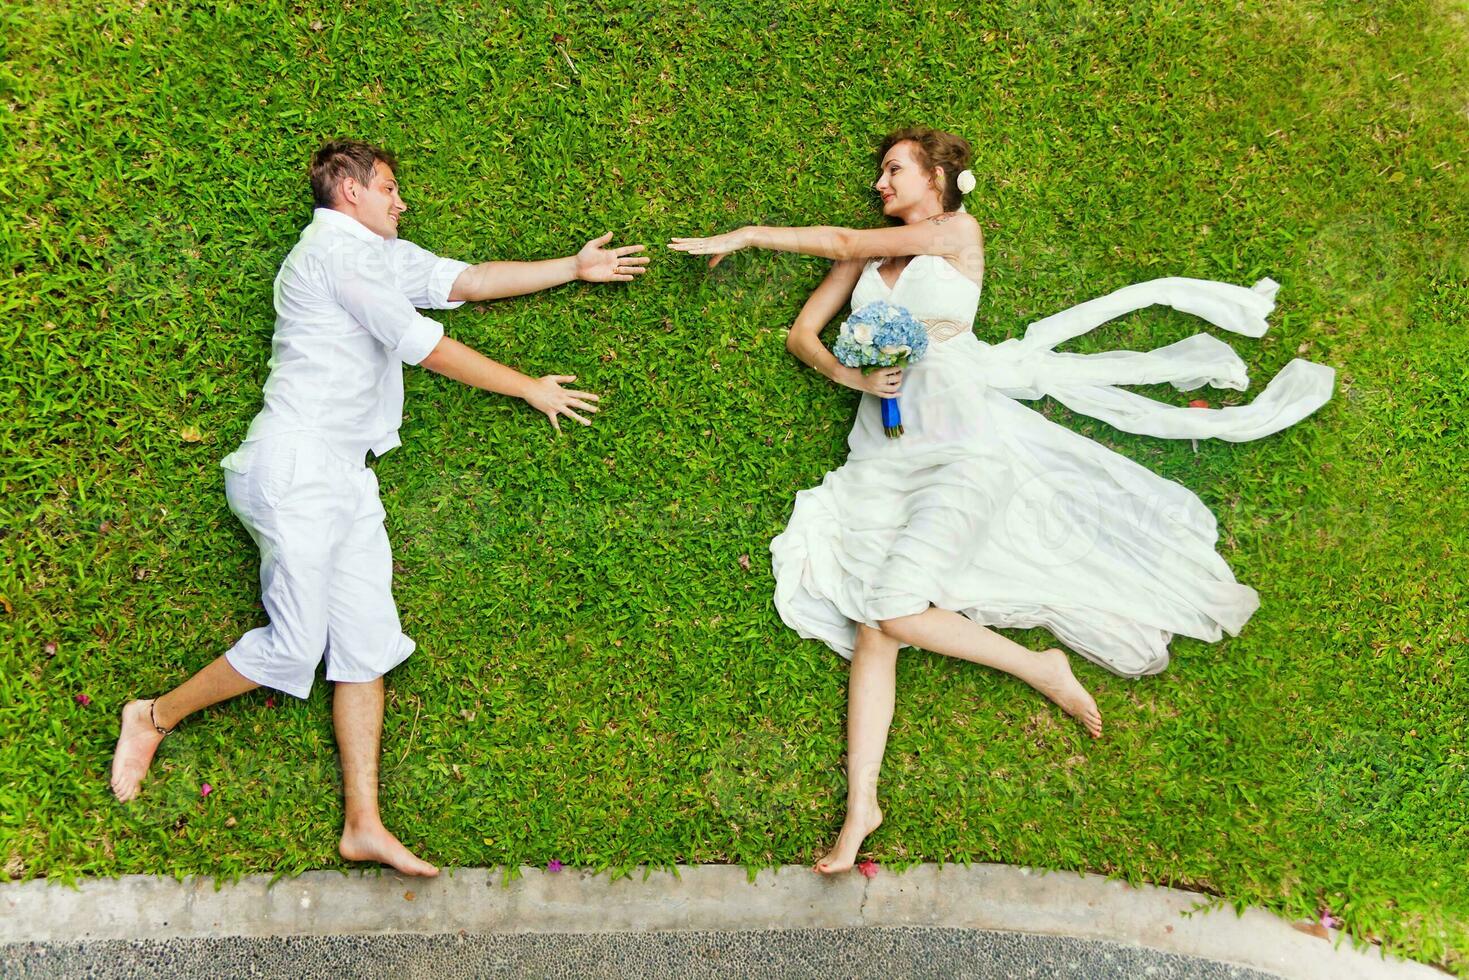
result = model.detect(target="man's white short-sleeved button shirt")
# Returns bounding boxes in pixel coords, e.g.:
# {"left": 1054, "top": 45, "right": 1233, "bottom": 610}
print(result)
{"left": 220, "top": 207, "right": 469, "bottom": 472}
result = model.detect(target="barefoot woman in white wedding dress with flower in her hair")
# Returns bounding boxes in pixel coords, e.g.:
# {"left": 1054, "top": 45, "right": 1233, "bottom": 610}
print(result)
{"left": 670, "top": 129, "right": 1332, "bottom": 874}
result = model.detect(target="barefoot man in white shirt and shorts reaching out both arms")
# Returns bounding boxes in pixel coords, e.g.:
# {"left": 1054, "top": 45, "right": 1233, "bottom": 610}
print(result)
{"left": 112, "top": 141, "right": 648, "bottom": 876}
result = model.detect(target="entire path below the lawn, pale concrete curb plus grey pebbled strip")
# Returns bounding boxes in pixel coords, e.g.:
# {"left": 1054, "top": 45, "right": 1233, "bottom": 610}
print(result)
{"left": 0, "top": 865, "right": 1443, "bottom": 980}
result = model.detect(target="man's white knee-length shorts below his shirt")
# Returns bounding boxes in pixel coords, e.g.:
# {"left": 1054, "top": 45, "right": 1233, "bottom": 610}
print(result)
{"left": 225, "top": 433, "right": 413, "bottom": 698}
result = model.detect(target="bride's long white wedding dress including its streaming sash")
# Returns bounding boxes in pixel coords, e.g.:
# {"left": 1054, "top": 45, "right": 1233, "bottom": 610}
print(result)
{"left": 770, "top": 256, "right": 1334, "bottom": 677}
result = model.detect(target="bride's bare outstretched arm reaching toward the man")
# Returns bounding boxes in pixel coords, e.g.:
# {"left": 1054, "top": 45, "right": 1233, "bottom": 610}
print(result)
{"left": 668, "top": 212, "right": 983, "bottom": 266}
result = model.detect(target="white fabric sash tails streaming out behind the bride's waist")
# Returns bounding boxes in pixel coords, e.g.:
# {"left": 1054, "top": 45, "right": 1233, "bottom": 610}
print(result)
{"left": 984, "top": 276, "right": 1337, "bottom": 442}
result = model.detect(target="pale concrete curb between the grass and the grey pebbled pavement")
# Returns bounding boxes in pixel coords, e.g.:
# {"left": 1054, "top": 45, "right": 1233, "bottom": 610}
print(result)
{"left": 0, "top": 864, "right": 1443, "bottom": 980}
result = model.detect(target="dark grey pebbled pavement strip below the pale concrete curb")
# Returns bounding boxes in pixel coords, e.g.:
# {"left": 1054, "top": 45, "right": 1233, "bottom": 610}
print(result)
{"left": 0, "top": 927, "right": 1275, "bottom": 980}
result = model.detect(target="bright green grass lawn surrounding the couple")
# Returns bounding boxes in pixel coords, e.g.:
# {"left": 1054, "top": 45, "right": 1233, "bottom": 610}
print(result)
{"left": 0, "top": 0, "right": 1469, "bottom": 976}
